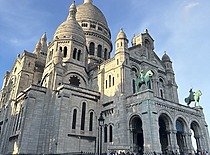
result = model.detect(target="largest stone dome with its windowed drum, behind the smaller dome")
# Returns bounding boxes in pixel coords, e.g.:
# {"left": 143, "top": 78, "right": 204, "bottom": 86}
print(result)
{"left": 76, "top": 0, "right": 112, "bottom": 63}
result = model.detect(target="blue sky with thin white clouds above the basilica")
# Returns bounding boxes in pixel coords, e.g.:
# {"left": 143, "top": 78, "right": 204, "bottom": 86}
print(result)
{"left": 0, "top": 0, "right": 210, "bottom": 144}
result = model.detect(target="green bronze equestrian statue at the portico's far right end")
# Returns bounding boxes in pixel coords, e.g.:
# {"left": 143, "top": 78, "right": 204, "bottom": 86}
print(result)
{"left": 185, "top": 89, "right": 202, "bottom": 107}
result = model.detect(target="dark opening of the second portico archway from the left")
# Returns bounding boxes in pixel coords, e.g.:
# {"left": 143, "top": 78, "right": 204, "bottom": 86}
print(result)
{"left": 158, "top": 117, "right": 169, "bottom": 152}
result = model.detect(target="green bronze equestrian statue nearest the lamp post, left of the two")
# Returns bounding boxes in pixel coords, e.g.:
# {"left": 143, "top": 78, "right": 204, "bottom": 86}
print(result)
{"left": 136, "top": 70, "right": 153, "bottom": 91}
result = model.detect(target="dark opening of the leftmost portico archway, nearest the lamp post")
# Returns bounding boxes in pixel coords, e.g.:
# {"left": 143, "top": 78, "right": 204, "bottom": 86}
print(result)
{"left": 130, "top": 116, "right": 144, "bottom": 154}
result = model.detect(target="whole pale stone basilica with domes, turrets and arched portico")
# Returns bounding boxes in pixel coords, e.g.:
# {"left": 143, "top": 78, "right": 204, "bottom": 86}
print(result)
{"left": 0, "top": 0, "right": 210, "bottom": 154}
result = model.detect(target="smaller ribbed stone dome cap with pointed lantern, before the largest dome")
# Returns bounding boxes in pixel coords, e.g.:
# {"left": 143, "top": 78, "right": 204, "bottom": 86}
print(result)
{"left": 54, "top": 3, "right": 85, "bottom": 42}
